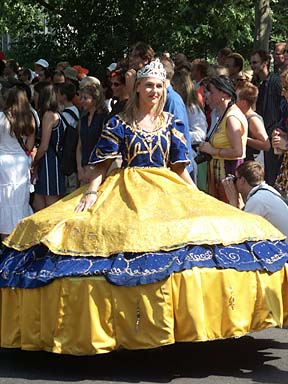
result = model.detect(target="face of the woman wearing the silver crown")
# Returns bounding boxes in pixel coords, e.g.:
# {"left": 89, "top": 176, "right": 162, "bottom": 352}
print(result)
{"left": 137, "top": 77, "right": 164, "bottom": 107}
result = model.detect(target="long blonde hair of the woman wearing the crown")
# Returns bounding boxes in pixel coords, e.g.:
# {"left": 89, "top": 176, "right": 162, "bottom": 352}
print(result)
{"left": 123, "top": 78, "right": 167, "bottom": 126}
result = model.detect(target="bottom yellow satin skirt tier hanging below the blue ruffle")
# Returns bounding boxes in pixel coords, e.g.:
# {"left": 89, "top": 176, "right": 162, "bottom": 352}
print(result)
{"left": 0, "top": 266, "right": 288, "bottom": 355}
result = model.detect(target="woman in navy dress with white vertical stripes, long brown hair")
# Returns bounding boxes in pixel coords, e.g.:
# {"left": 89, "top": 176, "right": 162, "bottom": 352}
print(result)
{"left": 33, "top": 83, "right": 65, "bottom": 211}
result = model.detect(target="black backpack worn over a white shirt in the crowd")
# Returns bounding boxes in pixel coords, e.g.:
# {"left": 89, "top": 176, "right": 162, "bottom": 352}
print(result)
{"left": 59, "top": 108, "right": 79, "bottom": 176}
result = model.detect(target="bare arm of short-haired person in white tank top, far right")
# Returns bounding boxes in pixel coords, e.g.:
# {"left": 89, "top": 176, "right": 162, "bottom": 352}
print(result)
{"left": 247, "top": 116, "right": 270, "bottom": 151}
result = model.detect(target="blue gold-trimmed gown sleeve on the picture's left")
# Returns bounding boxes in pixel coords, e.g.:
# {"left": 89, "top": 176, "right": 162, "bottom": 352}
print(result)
{"left": 89, "top": 116, "right": 124, "bottom": 164}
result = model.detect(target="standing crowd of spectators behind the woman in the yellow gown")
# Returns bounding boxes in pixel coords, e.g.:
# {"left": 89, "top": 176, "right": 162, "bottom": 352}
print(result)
{"left": 0, "top": 42, "right": 288, "bottom": 237}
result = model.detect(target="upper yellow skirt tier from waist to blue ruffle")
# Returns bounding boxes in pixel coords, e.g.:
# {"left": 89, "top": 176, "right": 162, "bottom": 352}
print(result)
{"left": 4, "top": 168, "right": 284, "bottom": 257}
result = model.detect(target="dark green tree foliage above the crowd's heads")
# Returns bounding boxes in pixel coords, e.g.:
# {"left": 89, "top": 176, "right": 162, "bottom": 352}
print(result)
{"left": 0, "top": 0, "right": 288, "bottom": 76}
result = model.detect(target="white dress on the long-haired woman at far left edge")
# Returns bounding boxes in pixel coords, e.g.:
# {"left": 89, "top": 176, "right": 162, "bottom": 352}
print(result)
{"left": 0, "top": 112, "right": 33, "bottom": 234}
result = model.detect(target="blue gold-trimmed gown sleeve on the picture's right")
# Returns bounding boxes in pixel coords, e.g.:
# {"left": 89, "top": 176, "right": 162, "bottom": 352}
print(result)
{"left": 169, "top": 118, "right": 190, "bottom": 164}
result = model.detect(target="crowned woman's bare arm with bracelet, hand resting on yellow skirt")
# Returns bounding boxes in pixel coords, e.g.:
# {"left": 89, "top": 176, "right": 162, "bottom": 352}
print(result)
{"left": 75, "top": 159, "right": 114, "bottom": 212}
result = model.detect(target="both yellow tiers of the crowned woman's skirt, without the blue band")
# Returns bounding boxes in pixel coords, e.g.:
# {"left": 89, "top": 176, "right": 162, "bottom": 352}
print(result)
{"left": 0, "top": 168, "right": 288, "bottom": 354}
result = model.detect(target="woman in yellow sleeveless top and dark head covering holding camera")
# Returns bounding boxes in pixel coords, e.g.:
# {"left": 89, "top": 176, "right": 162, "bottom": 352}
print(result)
{"left": 200, "top": 76, "right": 248, "bottom": 202}
